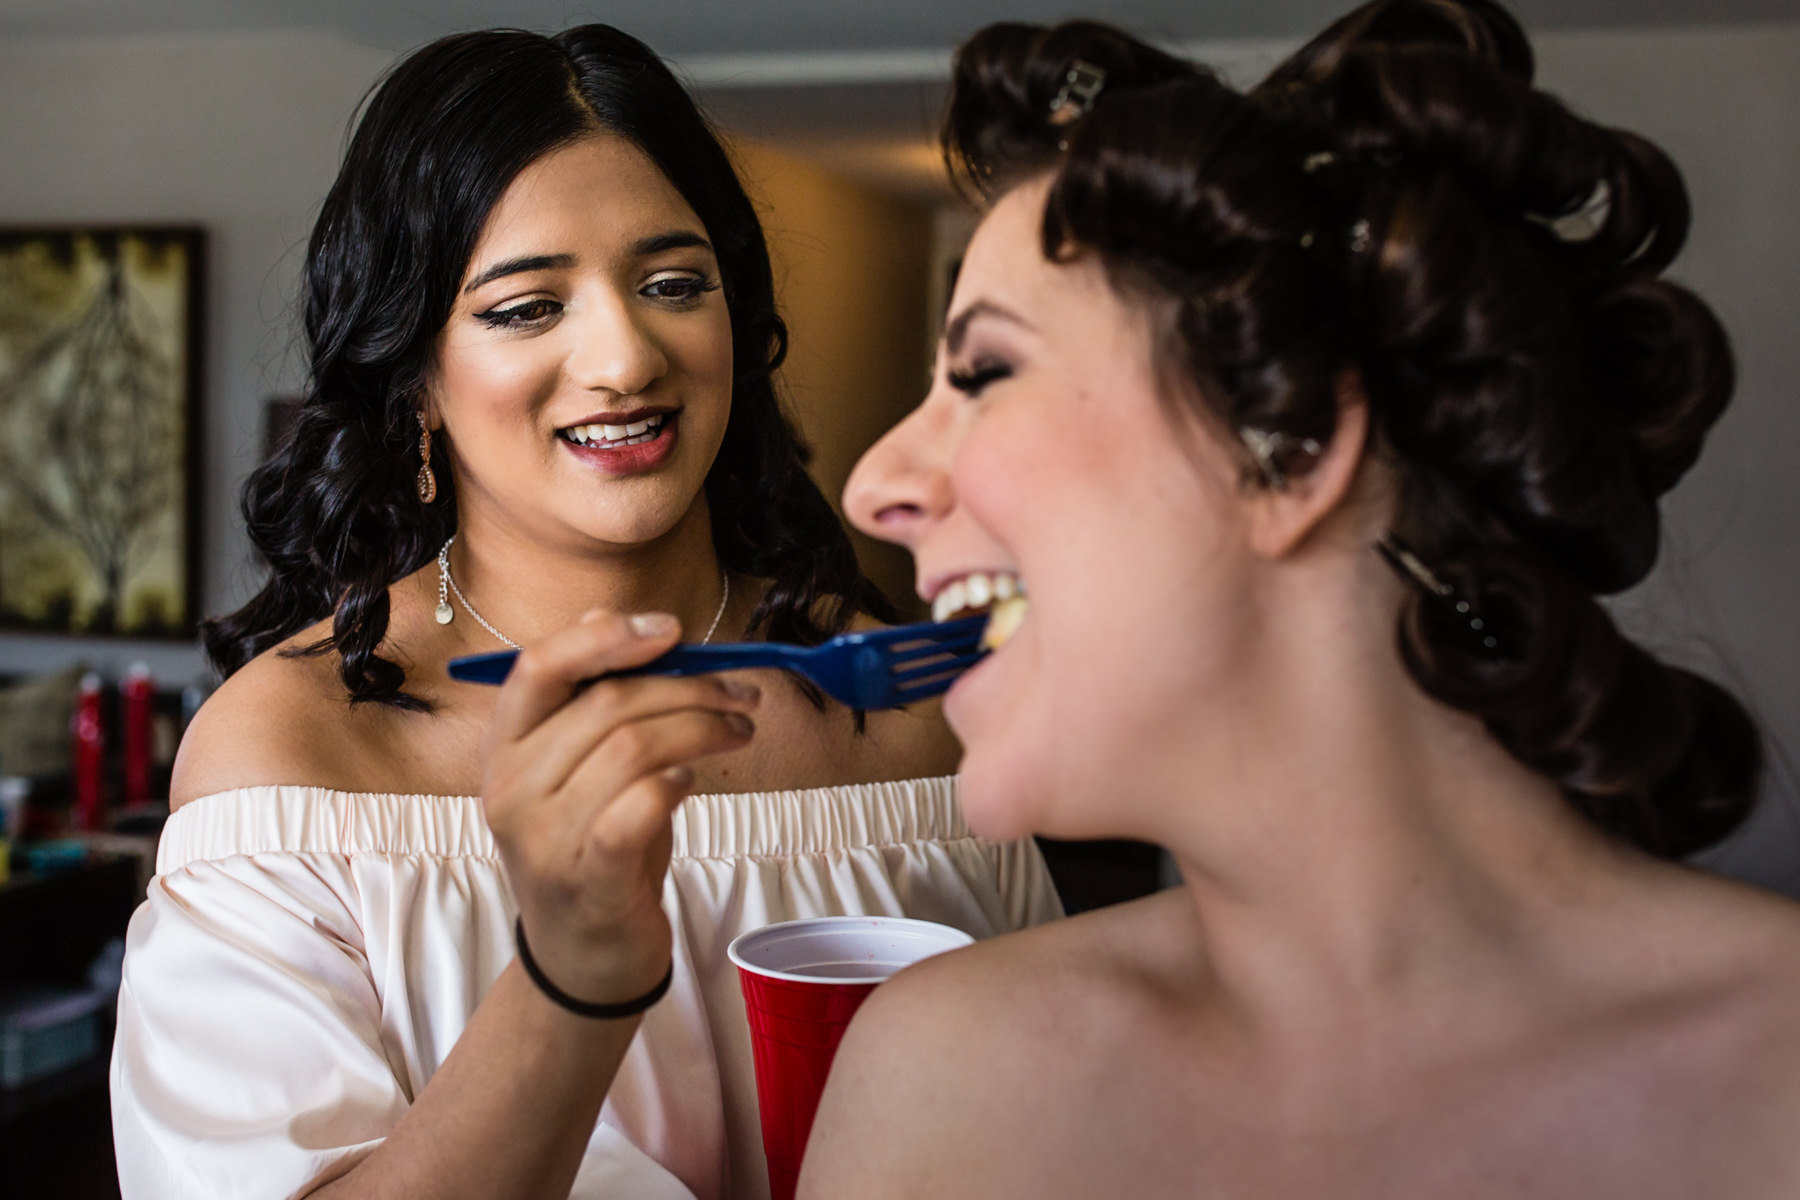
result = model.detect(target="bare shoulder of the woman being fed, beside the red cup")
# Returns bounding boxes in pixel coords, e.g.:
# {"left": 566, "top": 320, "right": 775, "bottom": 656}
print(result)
{"left": 801, "top": 894, "right": 1184, "bottom": 1196}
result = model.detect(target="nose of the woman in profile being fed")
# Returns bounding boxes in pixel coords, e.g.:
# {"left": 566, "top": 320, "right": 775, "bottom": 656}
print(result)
{"left": 844, "top": 399, "right": 956, "bottom": 547}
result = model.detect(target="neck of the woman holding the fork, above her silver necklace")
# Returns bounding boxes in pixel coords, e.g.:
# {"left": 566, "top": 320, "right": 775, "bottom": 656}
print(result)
{"left": 432, "top": 497, "right": 734, "bottom": 646}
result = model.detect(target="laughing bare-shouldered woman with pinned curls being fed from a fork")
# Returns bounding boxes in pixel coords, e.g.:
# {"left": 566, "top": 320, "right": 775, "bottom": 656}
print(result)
{"left": 801, "top": 0, "right": 1800, "bottom": 1200}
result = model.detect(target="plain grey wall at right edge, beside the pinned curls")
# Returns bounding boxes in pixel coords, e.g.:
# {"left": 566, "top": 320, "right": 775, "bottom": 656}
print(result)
{"left": 1539, "top": 23, "right": 1800, "bottom": 896}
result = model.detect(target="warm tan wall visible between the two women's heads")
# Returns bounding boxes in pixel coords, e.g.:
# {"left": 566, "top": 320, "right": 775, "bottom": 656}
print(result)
{"left": 733, "top": 142, "right": 932, "bottom": 604}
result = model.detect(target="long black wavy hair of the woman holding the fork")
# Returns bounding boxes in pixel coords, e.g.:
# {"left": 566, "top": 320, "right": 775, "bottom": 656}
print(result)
{"left": 203, "top": 25, "right": 895, "bottom": 711}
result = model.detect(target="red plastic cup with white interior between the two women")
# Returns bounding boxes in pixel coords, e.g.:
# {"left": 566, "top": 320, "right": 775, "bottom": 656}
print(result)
{"left": 727, "top": 918, "right": 974, "bottom": 1200}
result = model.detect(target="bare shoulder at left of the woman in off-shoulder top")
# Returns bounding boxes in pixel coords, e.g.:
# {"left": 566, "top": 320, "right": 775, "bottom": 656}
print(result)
{"left": 169, "top": 624, "right": 379, "bottom": 808}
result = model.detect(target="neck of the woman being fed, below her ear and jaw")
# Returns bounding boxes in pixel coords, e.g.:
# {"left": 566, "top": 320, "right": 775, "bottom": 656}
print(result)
{"left": 1156, "top": 556, "right": 1629, "bottom": 1038}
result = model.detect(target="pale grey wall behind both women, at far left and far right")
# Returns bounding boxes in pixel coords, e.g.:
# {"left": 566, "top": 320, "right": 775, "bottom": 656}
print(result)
{"left": 0, "top": 23, "right": 1800, "bottom": 894}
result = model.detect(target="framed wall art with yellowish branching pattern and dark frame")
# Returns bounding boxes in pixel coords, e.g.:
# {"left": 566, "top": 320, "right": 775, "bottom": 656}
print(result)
{"left": 0, "top": 227, "right": 205, "bottom": 637}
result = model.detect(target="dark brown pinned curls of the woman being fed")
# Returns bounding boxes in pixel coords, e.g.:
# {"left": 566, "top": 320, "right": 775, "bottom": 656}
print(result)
{"left": 943, "top": 0, "right": 1762, "bottom": 858}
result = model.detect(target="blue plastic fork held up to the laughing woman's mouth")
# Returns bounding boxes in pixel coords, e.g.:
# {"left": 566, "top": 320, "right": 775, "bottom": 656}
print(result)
{"left": 450, "top": 615, "right": 988, "bottom": 709}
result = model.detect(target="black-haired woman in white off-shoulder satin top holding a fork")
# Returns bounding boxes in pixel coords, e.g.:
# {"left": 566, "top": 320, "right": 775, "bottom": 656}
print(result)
{"left": 112, "top": 25, "right": 1058, "bottom": 1200}
